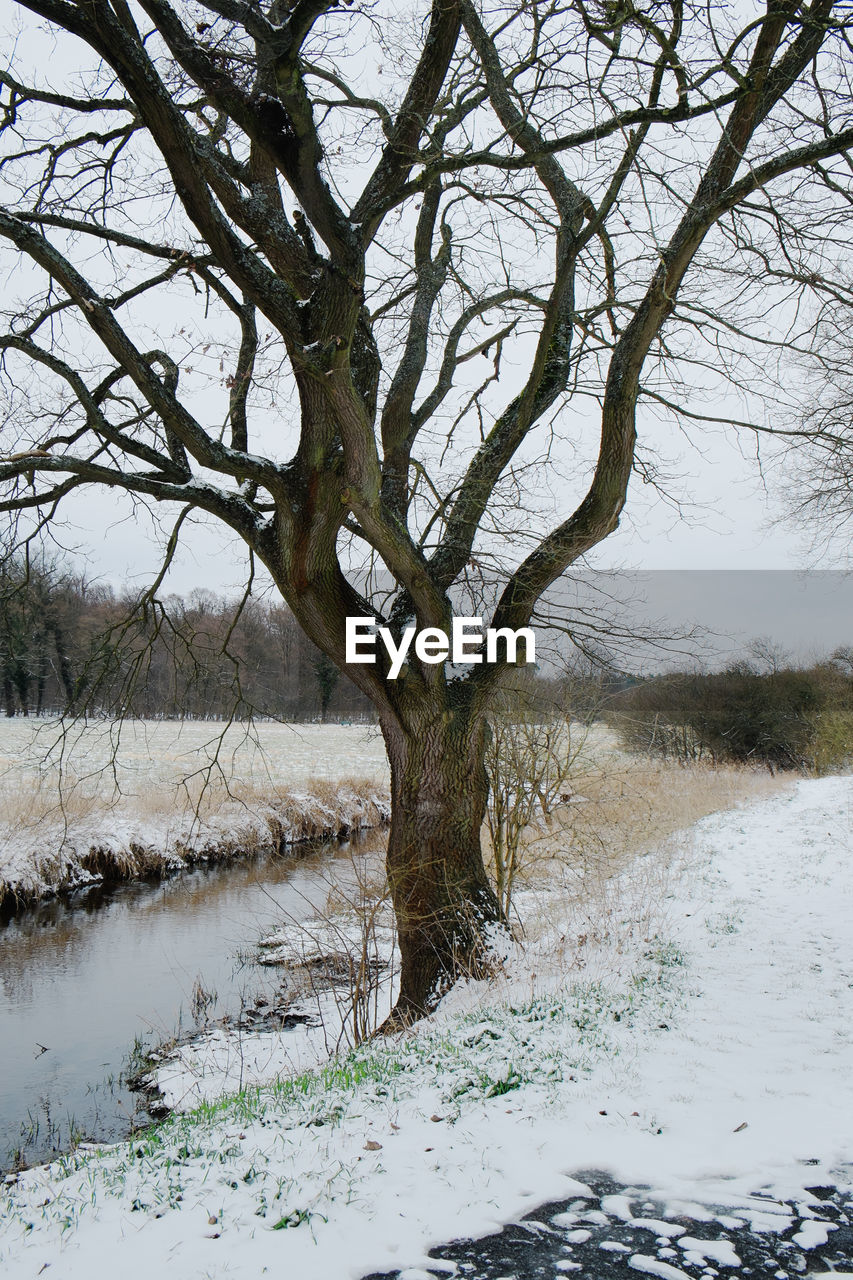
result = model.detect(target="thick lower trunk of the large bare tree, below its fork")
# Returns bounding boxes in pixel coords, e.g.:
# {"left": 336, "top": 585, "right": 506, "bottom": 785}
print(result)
{"left": 383, "top": 699, "right": 506, "bottom": 1027}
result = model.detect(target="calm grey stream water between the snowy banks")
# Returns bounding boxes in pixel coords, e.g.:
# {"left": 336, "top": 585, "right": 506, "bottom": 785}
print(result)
{"left": 0, "top": 835, "right": 380, "bottom": 1169}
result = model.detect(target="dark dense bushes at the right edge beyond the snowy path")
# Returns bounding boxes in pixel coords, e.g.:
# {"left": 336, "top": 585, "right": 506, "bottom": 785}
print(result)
{"left": 606, "top": 649, "right": 853, "bottom": 773}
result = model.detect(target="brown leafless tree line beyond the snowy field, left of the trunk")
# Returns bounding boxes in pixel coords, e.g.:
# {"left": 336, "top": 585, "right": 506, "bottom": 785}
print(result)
{"left": 0, "top": 556, "right": 371, "bottom": 721}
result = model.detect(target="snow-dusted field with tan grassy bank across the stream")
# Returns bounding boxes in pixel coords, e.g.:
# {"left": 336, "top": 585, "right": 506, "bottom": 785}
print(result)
{"left": 0, "top": 719, "right": 388, "bottom": 905}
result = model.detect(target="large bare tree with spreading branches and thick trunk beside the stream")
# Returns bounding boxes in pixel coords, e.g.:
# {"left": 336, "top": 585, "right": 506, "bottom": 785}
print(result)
{"left": 0, "top": 0, "right": 853, "bottom": 1020}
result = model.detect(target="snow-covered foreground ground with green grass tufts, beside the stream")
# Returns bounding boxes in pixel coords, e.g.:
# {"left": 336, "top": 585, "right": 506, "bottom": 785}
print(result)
{"left": 0, "top": 778, "right": 853, "bottom": 1280}
